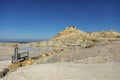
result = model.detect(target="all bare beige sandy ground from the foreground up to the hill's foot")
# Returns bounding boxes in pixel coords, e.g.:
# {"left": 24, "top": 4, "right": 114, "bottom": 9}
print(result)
{"left": 0, "top": 41, "right": 120, "bottom": 80}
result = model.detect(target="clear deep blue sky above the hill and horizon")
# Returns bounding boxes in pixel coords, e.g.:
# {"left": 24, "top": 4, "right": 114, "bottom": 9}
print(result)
{"left": 0, "top": 0, "right": 120, "bottom": 39}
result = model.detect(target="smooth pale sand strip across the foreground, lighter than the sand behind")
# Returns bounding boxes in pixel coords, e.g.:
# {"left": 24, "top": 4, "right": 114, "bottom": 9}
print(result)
{"left": 1, "top": 62, "right": 120, "bottom": 80}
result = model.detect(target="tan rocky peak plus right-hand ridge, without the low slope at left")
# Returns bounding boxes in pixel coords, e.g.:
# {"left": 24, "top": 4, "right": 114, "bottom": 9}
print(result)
{"left": 51, "top": 26, "right": 120, "bottom": 47}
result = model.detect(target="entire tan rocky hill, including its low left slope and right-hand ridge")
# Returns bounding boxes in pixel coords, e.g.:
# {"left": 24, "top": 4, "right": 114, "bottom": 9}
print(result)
{"left": 29, "top": 26, "right": 120, "bottom": 48}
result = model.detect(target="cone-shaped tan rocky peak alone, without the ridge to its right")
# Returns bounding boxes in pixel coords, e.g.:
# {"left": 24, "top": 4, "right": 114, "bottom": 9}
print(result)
{"left": 51, "top": 26, "right": 94, "bottom": 48}
